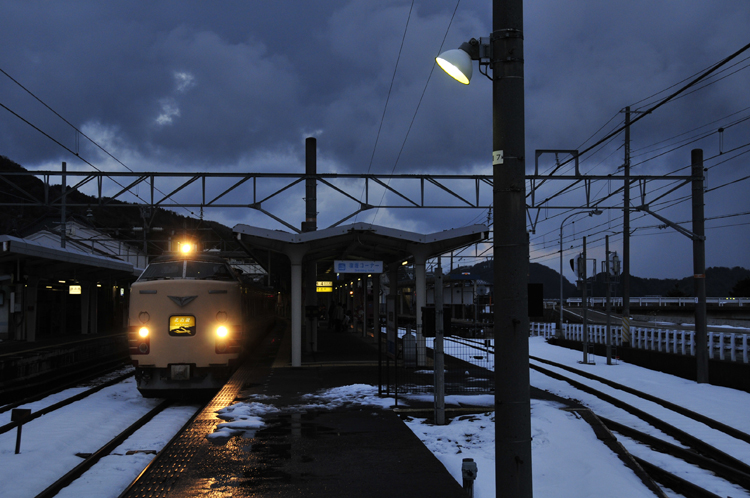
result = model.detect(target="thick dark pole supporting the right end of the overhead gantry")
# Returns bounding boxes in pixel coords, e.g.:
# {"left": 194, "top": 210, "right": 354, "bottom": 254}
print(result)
{"left": 690, "top": 149, "right": 708, "bottom": 384}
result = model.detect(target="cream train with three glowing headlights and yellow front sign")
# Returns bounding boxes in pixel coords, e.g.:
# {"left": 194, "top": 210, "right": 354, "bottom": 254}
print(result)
{"left": 127, "top": 244, "right": 274, "bottom": 398}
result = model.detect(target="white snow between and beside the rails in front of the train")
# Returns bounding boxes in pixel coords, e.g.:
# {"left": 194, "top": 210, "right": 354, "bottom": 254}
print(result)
{"left": 0, "top": 377, "right": 196, "bottom": 498}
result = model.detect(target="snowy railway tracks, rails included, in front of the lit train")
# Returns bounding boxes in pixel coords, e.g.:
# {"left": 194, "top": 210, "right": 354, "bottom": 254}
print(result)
{"left": 0, "top": 370, "right": 201, "bottom": 498}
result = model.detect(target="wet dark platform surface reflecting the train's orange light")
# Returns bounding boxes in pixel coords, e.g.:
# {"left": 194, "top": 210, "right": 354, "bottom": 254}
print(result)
{"left": 121, "top": 320, "right": 464, "bottom": 498}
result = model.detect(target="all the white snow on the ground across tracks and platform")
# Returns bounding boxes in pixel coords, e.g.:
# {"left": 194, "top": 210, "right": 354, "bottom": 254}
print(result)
{"left": 0, "top": 337, "right": 750, "bottom": 498}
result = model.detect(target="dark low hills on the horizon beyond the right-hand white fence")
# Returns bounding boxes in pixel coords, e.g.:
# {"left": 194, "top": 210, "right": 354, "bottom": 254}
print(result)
{"left": 452, "top": 260, "right": 750, "bottom": 299}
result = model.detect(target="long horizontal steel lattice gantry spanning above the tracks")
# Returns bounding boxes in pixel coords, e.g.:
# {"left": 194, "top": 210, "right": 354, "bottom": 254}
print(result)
{"left": 0, "top": 165, "right": 693, "bottom": 232}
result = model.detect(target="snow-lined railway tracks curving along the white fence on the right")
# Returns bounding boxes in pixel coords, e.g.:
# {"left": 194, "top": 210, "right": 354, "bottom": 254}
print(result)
{"left": 446, "top": 338, "right": 750, "bottom": 498}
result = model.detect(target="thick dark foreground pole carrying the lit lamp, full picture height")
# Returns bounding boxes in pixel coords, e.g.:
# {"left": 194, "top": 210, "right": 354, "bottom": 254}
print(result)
{"left": 490, "top": 0, "right": 533, "bottom": 498}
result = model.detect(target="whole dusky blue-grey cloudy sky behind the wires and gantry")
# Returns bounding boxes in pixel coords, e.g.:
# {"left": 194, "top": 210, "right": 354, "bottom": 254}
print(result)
{"left": 0, "top": 0, "right": 750, "bottom": 279}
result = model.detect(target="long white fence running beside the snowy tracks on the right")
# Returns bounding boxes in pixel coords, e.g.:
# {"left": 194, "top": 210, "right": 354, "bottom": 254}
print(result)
{"left": 530, "top": 322, "right": 750, "bottom": 363}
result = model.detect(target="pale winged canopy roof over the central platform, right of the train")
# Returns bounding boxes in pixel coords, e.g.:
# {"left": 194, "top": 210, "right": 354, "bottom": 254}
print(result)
{"left": 234, "top": 223, "right": 489, "bottom": 273}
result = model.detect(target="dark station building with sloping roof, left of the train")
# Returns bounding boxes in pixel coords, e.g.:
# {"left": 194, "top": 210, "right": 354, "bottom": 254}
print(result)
{"left": 0, "top": 219, "right": 147, "bottom": 342}
